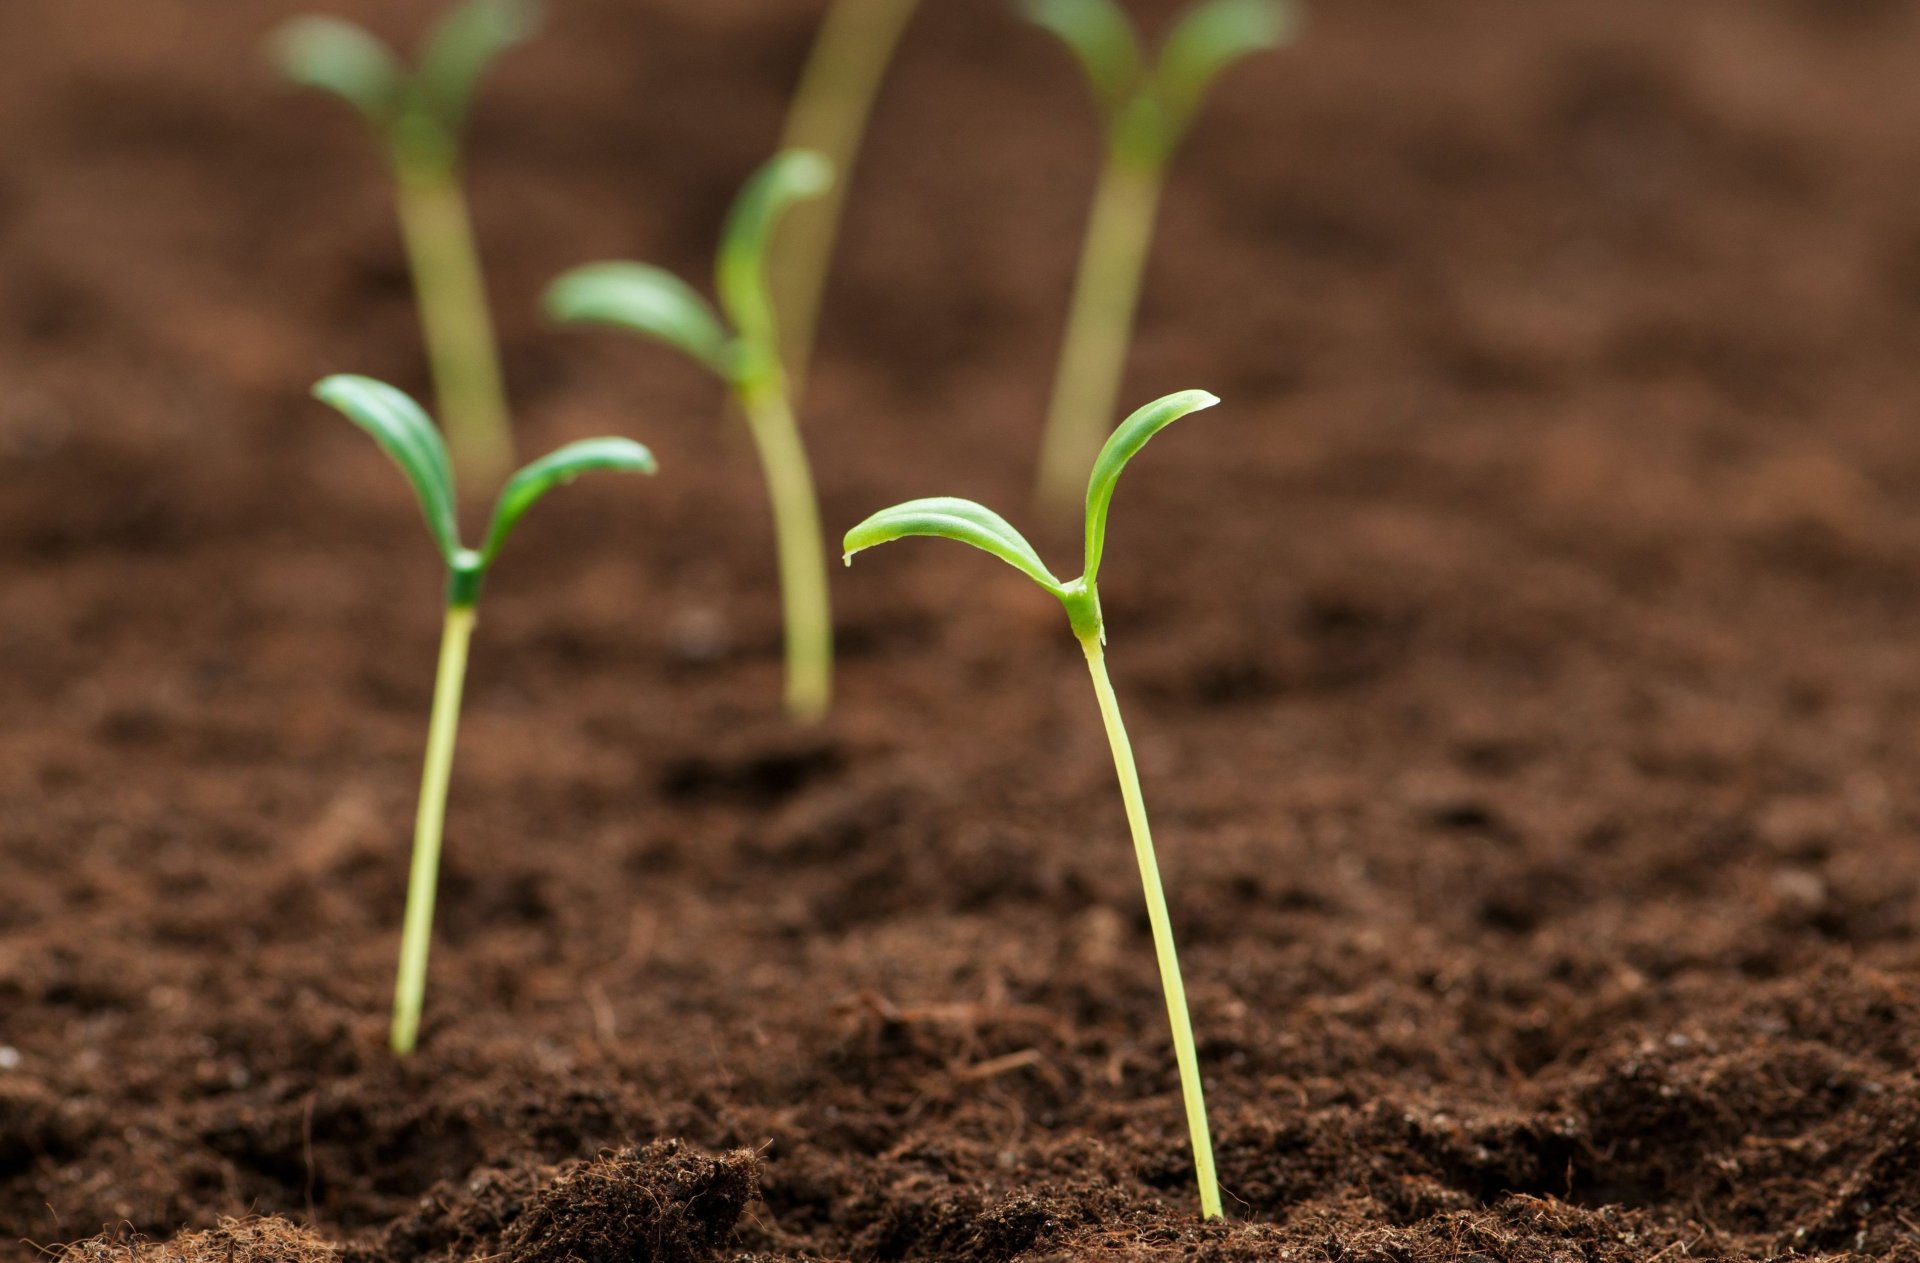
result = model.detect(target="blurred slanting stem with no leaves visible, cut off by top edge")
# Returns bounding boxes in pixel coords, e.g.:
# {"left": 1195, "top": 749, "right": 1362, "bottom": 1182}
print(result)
{"left": 772, "top": 0, "right": 920, "bottom": 397}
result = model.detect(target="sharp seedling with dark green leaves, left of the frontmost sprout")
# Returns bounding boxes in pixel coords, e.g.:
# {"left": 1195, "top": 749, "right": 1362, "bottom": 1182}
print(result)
{"left": 313, "top": 376, "right": 655, "bottom": 1056}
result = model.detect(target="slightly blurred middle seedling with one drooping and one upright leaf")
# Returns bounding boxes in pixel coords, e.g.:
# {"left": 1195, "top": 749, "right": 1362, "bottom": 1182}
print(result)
{"left": 547, "top": 150, "right": 833, "bottom": 722}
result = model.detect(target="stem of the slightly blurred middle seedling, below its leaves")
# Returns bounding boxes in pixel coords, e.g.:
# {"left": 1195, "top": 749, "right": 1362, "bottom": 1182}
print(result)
{"left": 739, "top": 386, "right": 833, "bottom": 724}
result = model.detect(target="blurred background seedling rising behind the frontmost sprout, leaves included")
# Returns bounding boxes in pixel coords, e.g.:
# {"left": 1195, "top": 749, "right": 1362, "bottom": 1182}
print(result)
{"left": 1023, "top": 0, "right": 1296, "bottom": 514}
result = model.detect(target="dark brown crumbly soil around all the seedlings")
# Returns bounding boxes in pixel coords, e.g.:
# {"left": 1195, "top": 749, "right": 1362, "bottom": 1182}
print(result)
{"left": 0, "top": 0, "right": 1920, "bottom": 1263}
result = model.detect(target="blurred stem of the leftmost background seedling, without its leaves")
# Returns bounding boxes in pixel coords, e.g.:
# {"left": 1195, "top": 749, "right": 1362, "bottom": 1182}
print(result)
{"left": 396, "top": 157, "right": 513, "bottom": 486}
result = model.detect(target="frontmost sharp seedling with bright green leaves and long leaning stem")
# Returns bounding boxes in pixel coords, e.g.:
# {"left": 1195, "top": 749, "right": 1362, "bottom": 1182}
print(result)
{"left": 845, "top": 390, "right": 1221, "bottom": 1219}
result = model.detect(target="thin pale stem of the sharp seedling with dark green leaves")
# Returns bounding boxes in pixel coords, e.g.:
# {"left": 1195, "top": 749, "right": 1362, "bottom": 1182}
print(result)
{"left": 392, "top": 605, "right": 474, "bottom": 1056}
